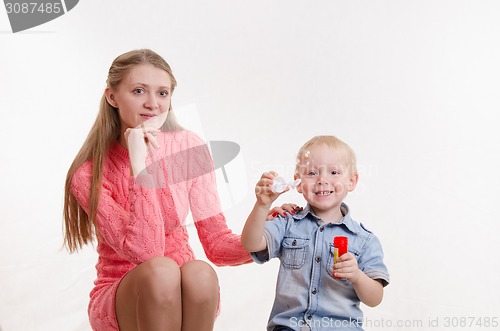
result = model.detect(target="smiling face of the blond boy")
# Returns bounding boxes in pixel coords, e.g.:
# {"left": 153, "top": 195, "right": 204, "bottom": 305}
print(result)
{"left": 296, "top": 144, "right": 358, "bottom": 217}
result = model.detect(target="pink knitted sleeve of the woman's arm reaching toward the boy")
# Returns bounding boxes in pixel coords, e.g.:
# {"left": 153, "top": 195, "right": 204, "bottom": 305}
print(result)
{"left": 185, "top": 134, "right": 252, "bottom": 266}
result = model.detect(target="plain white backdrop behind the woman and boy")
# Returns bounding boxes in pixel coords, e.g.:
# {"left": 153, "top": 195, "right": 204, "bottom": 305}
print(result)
{"left": 0, "top": 0, "right": 500, "bottom": 331}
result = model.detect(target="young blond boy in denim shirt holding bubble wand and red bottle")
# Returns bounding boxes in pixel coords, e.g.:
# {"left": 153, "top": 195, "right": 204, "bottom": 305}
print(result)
{"left": 241, "top": 136, "right": 389, "bottom": 331}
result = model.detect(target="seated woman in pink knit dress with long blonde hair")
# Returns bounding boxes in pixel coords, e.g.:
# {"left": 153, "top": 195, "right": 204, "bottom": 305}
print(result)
{"left": 64, "top": 49, "right": 289, "bottom": 331}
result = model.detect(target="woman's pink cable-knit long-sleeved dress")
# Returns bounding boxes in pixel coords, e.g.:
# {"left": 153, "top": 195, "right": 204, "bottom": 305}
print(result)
{"left": 71, "top": 131, "right": 251, "bottom": 331}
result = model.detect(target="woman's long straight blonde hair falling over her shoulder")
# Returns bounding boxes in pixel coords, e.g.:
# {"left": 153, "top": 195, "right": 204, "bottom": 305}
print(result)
{"left": 64, "top": 49, "right": 182, "bottom": 252}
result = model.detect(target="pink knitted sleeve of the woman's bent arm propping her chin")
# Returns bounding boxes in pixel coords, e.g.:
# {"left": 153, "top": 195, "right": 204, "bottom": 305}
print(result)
{"left": 71, "top": 162, "right": 165, "bottom": 264}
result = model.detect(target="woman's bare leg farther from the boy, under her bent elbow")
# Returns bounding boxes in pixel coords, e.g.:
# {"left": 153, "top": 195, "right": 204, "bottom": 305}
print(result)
{"left": 115, "top": 257, "right": 182, "bottom": 331}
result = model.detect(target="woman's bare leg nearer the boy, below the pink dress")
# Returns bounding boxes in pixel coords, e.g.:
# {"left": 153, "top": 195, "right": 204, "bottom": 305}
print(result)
{"left": 181, "top": 260, "right": 219, "bottom": 331}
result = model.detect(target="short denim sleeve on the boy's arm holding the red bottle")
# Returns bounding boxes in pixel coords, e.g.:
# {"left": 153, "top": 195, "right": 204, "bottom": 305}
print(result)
{"left": 358, "top": 234, "right": 389, "bottom": 287}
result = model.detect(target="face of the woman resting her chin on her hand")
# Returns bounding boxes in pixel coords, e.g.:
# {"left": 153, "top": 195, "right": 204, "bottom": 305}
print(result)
{"left": 106, "top": 64, "right": 172, "bottom": 137}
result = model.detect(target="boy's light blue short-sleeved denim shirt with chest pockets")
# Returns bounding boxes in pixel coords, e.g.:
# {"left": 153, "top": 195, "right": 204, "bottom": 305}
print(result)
{"left": 252, "top": 204, "right": 389, "bottom": 330}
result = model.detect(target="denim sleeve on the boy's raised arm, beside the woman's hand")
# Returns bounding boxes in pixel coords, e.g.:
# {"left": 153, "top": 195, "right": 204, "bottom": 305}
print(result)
{"left": 250, "top": 214, "right": 291, "bottom": 264}
